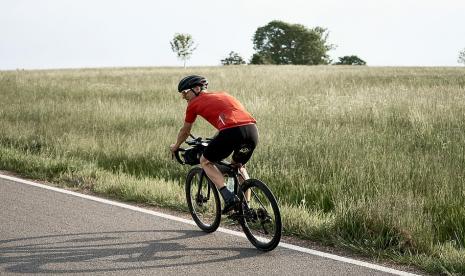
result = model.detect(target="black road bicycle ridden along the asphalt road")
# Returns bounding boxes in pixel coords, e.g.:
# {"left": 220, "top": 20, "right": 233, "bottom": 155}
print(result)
{"left": 174, "top": 135, "right": 282, "bottom": 251}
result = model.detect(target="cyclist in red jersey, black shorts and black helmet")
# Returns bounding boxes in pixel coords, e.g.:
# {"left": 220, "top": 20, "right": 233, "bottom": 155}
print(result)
{"left": 170, "top": 75, "right": 258, "bottom": 214}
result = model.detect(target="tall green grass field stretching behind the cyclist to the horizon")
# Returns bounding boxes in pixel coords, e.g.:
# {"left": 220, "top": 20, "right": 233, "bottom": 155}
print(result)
{"left": 0, "top": 66, "right": 465, "bottom": 274}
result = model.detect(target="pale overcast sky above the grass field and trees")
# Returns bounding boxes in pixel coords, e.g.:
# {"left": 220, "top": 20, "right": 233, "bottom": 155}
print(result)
{"left": 0, "top": 0, "right": 465, "bottom": 70}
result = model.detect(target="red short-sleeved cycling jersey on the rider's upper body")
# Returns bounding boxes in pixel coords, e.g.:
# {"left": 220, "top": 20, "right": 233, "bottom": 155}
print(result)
{"left": 185, "top": 92, "right": 256, "bottom": 130}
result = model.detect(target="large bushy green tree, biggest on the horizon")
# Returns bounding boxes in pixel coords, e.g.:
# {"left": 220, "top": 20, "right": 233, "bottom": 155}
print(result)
{"left": 251, "top": 20, "right": 334, "bottom": 65}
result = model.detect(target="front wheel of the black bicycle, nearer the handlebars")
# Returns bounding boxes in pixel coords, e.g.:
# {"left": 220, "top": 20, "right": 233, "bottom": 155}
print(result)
{"left": 185, "top": 167, "right": 221, "bottom": 233}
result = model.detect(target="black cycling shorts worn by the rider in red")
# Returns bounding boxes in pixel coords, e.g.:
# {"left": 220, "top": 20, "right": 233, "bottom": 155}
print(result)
{"left": 203, "top": 124, "right": 258, "bottom": 165}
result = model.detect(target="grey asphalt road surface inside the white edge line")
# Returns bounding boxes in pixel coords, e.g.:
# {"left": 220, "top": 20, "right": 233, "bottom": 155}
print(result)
{"left": 0, "top": 178, "right": 418, "bottom": 275}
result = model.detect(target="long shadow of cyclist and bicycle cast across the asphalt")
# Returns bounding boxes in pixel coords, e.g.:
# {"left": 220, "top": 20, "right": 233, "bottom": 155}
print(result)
{"left": 0, "top": 230, "right": 261, "bottom": 273}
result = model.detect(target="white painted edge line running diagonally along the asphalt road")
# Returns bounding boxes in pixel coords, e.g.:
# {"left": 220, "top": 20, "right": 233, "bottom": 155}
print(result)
{"left": 0, "top": 174, "right": 417, "bottom": 276}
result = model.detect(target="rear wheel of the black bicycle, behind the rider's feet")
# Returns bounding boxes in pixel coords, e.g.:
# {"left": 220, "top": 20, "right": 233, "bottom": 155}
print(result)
{"left": 239, "top": 179, "right": 282, "bottom": 251}
